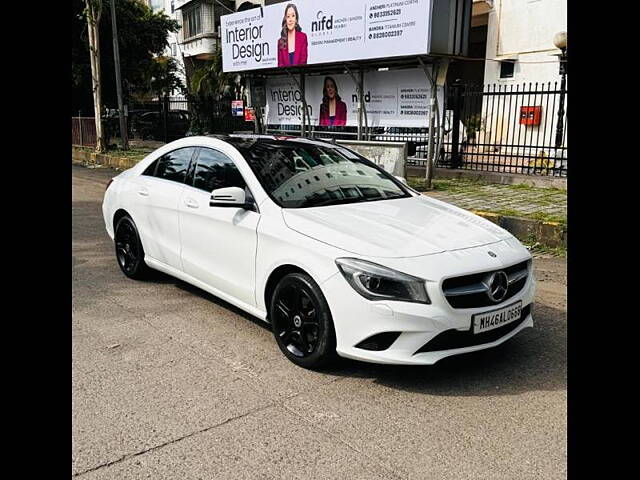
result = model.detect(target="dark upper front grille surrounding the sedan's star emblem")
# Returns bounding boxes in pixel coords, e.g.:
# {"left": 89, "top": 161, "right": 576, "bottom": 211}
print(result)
{"left": 442, "top": 260, "right": 530, "bottom": 308}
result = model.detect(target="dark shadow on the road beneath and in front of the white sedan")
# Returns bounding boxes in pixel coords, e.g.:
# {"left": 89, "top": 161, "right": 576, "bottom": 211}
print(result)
{"left": 151, "top": 272, "right": 567, "bottom": 396}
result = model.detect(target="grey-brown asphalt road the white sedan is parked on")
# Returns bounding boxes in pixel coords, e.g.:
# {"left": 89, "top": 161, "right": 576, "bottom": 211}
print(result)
{"left": 72, "top": 166, "right": 567, "bottom": 480}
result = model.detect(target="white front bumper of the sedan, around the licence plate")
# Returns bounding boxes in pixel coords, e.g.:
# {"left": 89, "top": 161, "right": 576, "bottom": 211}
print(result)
{"left": 321, "top": 266, "right": 535, "bottom": 365}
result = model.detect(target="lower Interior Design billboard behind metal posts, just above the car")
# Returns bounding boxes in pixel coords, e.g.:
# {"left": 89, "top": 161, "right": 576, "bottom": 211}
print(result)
{"left": 266, "top": 69, "right": 444, "bottom": 127}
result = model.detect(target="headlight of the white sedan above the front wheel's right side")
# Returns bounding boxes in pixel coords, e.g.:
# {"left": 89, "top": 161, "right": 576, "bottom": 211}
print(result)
{"left": 336, "top": 258, "right": 431, "bottom": 303}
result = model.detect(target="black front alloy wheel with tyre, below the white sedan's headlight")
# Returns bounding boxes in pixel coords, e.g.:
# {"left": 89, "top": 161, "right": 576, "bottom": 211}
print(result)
{"left": 269, "top": 273, "right": 337, "bottom": 368}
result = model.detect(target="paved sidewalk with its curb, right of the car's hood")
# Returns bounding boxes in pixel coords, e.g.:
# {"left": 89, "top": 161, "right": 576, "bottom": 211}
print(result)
{"left": 408, "top": 177, "right": 567, "bottom": 249}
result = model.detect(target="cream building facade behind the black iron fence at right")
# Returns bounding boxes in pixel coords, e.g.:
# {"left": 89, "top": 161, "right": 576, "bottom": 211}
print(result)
{"left": 456, "top": 0, "right": 567, "bottom": 171}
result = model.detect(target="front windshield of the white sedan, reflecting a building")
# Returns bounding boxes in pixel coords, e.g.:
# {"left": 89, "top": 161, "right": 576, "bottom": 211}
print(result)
{"left": 237, "top": 140, "right": 410, "bottom": 208}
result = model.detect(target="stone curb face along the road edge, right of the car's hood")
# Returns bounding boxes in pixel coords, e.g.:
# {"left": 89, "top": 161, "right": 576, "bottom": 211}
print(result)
{"left": 470, "top": 210, "right": 567, "bottom": 248}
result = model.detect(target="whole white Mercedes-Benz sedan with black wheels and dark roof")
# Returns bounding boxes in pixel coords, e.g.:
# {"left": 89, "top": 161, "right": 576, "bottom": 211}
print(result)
{"left": 102, "top": 135, "right": 535, "bottom": 368}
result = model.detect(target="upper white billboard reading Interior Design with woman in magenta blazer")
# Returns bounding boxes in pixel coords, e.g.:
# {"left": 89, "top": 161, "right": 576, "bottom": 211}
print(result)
{"left": 220, "top": 0, "right": 432, "bottom": 72}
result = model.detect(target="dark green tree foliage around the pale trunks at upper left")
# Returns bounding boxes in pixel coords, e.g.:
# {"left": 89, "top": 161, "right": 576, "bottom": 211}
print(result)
{"left": 71, "top": 0, "right": 181, "bottom": 115}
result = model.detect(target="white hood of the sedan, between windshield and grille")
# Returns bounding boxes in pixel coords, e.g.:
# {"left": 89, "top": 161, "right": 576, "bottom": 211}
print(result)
{"left": 282, "top": 195, "right": 512, "bottom": 258}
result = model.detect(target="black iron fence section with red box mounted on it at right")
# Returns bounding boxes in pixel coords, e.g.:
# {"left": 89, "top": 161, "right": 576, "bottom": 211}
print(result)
{"left": 437, "top": 82, "right": 568, "bottom": 177}
